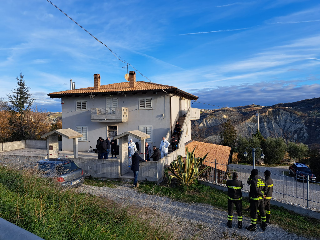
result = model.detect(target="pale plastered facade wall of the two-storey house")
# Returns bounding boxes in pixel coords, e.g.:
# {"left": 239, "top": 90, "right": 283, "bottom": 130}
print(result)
{"left": 62, "top": 92, "right": 172, "bottom": 151}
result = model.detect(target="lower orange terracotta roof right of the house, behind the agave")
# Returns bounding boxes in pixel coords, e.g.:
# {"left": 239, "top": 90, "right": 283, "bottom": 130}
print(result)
{"left": 186, "top": 141, "right": 231, "bottom": 172}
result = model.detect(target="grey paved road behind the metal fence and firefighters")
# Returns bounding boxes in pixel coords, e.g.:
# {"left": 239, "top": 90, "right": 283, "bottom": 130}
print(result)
{"left": 229, "top": 164, "right": 320, "bottom": 211}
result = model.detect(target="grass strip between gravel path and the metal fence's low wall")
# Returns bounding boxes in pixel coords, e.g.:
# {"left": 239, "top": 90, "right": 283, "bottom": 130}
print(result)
{"left": 139, "top": 182, "right": 320, "bottom": 238}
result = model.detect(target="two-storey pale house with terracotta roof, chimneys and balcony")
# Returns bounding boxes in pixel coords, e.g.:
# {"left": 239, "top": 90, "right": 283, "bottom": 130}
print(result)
{"left": 48, "top": 71, "right": 200, "bottom": 151}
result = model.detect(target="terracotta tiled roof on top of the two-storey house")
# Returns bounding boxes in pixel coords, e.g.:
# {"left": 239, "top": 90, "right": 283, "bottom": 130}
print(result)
{"left": 48, "top": 81, "right": 198, "bottom": 100}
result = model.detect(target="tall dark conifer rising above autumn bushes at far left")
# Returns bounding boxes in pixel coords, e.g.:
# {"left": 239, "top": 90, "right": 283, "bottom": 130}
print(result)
{"left": 8, "top": 73, "right": 34, "bottom": 114}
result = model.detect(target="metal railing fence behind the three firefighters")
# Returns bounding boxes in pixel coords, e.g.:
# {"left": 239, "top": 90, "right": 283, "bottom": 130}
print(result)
{"left": 200, "top": 163, "right": 320, "bottom": 211}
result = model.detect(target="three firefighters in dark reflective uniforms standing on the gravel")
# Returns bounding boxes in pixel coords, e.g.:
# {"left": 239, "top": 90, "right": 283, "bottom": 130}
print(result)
{"left": 227, "top": 169, "right": 273, "bottom": 231}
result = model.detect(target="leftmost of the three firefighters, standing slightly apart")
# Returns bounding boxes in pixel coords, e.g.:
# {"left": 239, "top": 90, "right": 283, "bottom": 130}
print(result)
{"left": 227, "top": 172, "right": 243, "bottom": 229}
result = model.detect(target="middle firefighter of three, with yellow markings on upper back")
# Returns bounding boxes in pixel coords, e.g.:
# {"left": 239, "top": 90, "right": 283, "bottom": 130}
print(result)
{"left": 246, "top": 169, "right": 267, "bottom": 231}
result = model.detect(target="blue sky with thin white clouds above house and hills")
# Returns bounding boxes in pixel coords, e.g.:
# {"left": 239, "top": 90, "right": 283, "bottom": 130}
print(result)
{"left": 0, "top": 0, "right": 320, "bottom": 111}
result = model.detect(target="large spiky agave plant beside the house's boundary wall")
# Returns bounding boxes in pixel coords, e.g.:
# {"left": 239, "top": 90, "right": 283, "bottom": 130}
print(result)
{"left": 168, "top": 148, "right": 209, "bottom": 186}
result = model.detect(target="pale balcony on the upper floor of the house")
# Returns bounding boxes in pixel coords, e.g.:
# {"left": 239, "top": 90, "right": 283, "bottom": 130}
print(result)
{"left": 91, "top": 107, "right": 128, "bottom": 123}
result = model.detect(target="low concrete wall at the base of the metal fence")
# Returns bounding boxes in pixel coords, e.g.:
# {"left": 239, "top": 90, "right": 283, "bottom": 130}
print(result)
{"left": 199, "top": 181, "right": 320, "bottom": 220}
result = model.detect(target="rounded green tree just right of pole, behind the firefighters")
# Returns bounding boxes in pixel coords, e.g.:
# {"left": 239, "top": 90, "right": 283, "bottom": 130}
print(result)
{"left": 262, "top": 137, "right": 287, "bottom": 164}
